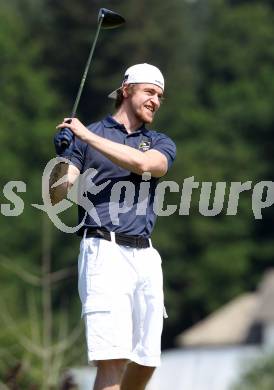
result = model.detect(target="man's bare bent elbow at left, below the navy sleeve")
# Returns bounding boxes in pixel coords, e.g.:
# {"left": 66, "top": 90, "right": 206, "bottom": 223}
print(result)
{"left": 49, "top": 162, "right": 80, "bottom": 205}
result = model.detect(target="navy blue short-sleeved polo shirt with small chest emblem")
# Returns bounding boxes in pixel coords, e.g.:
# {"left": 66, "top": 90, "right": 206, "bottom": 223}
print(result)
{"left": 70, "top": 116, "right": 176, "bottom": 237}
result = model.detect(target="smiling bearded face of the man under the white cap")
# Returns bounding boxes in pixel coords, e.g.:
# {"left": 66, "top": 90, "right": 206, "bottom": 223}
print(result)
{"left": 124, "top": 84, "right": 163, "bottom": 123}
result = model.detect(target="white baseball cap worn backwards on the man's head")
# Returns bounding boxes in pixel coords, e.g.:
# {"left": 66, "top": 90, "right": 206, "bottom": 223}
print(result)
{"left": 108, "top": 64, "right": 165, "bottom": 99}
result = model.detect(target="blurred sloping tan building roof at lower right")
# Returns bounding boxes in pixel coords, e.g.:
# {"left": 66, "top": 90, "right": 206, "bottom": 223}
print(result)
{"left": 176, "top": 269, "right": 274, "bottom": 347}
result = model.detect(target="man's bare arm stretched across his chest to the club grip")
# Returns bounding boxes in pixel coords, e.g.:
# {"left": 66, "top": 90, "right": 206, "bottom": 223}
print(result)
{"left": 58, "top": 118, "right": 168, "bottom": 177}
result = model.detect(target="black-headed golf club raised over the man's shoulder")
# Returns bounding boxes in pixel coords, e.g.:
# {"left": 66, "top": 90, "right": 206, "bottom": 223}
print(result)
{"left": 60, "top": 8, "right": 125, "bottom": 150}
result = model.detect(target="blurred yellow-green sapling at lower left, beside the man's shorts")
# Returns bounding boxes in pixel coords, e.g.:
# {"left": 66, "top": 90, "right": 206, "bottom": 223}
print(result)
{"left": 0, "top": 216, "right": 83, "bottom": 390}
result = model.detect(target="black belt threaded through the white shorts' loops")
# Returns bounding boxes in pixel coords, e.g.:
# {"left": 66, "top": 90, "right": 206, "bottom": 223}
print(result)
{"left": 83, "top": 228, "right": 150, "bottom": 248}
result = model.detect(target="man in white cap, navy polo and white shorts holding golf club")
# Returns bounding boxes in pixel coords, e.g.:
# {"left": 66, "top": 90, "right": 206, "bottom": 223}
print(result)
{"left": 51, "top": 64, "right": 176, "bottom": 390}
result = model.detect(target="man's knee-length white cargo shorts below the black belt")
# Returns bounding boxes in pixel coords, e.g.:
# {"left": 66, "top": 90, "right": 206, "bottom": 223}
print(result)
{"left": 78, "top": 237, "right": 165, "bottom": 367}
